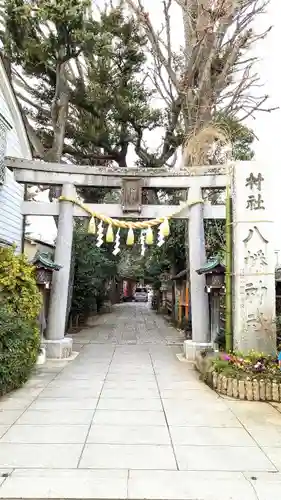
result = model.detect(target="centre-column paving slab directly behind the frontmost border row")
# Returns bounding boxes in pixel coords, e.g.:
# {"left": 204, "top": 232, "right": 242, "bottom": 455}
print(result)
{"left": 79, "top": 444, "right": 176, "bottom": 470}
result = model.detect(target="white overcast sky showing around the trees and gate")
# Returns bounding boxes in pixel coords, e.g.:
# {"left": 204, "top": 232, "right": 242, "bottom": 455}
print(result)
{"left": 26, "top": 0, "right": 281, "bottom": 248}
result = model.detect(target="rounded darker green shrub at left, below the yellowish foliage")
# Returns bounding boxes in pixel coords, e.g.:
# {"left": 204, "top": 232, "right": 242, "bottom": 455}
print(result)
{"left": 0, "top": 303, "right": 40, "bottom": 396}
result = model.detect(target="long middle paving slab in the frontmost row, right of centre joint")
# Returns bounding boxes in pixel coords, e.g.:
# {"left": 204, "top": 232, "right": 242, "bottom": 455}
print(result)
{"left": 128, "top": 470, "right": 256, "bottom": 500}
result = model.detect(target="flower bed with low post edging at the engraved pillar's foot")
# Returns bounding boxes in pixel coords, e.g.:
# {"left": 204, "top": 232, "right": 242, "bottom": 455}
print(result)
{"left": 205, "top": 352, "right": 281, "bottom": 402}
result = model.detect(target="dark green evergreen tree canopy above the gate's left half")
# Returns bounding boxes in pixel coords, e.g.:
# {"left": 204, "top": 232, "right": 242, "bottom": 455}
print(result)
{"left": 1, "top": 0, "right": 162, "bottom": 167}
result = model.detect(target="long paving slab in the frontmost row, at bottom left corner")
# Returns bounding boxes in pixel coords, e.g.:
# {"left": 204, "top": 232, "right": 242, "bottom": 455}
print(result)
{"left": 0, "top": 469, "right": 128, "bottom": 499}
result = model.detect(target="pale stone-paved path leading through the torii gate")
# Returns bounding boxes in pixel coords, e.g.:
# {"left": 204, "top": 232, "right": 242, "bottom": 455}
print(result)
{"left": 0, "top": 304, "right": 281, "bottom": 500}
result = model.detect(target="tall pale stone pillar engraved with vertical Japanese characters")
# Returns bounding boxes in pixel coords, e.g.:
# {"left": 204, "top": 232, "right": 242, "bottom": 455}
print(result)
{"left": 233, "top": 161, "right": 276, "bottom": 354}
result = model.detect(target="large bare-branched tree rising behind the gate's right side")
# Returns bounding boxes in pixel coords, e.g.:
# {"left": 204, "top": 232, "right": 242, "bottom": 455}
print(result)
{"left": 125, "top": 0, "right": 276, "bottom": 166}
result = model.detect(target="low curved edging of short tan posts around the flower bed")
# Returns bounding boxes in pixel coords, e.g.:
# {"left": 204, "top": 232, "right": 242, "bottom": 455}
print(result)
{"left": 208, "top": 372, "right": 281, "bottom": 402}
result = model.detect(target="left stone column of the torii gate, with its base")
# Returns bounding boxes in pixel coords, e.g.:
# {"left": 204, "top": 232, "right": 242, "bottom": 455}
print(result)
{"left": 46, "top": 184, "right": 75, "bottom": 358}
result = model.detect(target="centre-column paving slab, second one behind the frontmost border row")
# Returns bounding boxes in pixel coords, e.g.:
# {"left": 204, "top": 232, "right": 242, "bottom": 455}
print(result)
{"left": 87, "top": 424, "right": 170, "bottom": 445}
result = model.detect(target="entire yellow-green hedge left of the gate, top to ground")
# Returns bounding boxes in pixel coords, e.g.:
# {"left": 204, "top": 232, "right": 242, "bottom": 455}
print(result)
{"left": 0, "top": 248, "right": 42, "bottom": 395}
